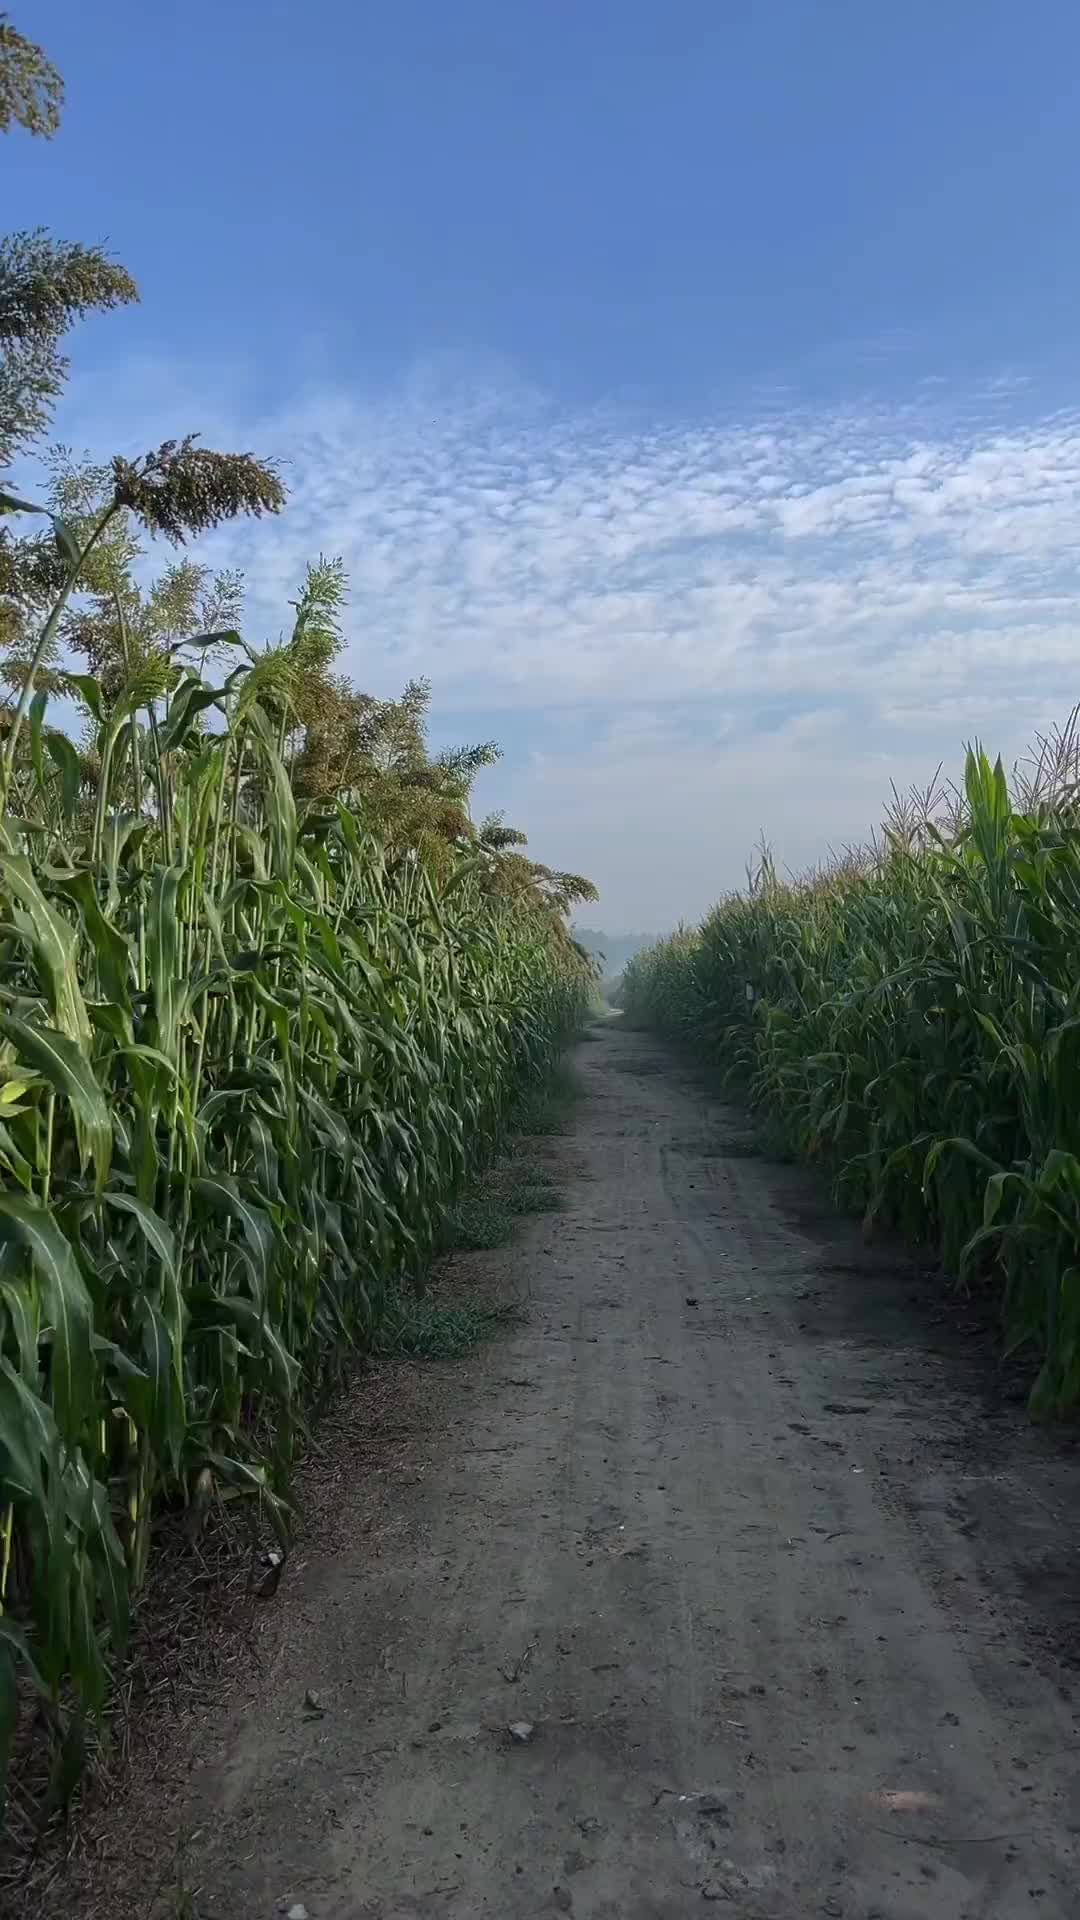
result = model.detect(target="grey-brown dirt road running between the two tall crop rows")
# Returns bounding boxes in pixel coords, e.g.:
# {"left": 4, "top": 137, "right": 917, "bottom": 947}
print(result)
{"left": 164, "top": 1021, "right": 1080, "bottom": 1920}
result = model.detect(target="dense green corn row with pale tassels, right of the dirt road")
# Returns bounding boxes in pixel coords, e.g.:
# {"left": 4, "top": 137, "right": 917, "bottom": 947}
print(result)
{"left": 623, "top": 751, "right": 1080, "bottom": 1415}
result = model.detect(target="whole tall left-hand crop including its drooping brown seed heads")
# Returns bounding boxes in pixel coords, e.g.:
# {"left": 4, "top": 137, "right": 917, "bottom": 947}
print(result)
{"left": 0, "top": 15, "right": 572, "bottom": 1835}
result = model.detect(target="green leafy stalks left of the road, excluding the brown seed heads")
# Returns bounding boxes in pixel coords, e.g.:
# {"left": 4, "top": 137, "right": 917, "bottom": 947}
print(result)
{"left": 0, "top": 645, "right": 590, "bottom": 1797}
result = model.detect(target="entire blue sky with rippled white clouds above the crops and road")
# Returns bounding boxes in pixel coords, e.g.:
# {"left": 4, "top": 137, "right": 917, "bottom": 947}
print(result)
{"left": 4, "top": 0, "right": 1080, "bottom": 927}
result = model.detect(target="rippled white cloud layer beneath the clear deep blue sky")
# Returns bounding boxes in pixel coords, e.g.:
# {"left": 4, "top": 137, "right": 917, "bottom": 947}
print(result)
{"left": 52, "top": 360, "right": 1080, "bottom": 924}
